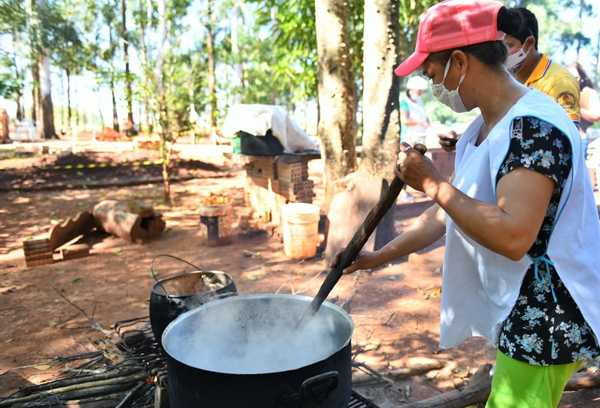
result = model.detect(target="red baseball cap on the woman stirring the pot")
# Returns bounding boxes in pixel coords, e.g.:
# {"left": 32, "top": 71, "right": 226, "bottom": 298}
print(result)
{"left": 394, "top": 0, "right": 504, "bottom": 76}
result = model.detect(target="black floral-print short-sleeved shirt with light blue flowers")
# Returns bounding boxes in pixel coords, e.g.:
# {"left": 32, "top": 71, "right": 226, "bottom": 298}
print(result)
{"left": 496, "top": 116, "right": 600, "bottom": 366}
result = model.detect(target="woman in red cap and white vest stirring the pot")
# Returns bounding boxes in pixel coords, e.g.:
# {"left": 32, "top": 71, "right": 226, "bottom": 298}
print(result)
{"left": 336, "top": 0, "right": 600, "bottom": 408}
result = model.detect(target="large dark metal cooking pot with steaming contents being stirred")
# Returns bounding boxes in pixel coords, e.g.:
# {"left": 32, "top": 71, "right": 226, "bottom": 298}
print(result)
{"left": 162, "top": 294, "right": 354, "bottom": 408}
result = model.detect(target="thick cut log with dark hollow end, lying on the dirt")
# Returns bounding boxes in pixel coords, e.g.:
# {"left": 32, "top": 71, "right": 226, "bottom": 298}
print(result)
{"left": 93, "top": 200, "right": 165, "bottom": 242}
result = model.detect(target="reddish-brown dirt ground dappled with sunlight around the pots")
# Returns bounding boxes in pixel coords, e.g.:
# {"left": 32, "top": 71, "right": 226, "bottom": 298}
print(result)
{"left": 0, "top": 142, "right": 600, "bottom": 408}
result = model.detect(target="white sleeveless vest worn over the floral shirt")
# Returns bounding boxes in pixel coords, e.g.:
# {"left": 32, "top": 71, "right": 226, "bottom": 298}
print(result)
{"left": 440, "top": 90, "right": 600, "bottom": 348}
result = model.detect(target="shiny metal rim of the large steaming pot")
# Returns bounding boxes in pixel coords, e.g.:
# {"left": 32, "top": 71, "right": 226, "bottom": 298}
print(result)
{"left": 161, "top": 293, "right": 355, "bottom": 375}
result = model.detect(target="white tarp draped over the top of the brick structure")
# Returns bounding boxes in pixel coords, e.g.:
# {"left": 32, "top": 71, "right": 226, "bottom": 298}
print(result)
{"left": 221, "top": 104, "right": 319, "bottom": 153}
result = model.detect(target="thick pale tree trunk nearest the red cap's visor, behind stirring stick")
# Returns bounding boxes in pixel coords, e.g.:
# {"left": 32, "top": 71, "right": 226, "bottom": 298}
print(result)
{"left": 361, "top": 0, "right": 400, "bottom": 179}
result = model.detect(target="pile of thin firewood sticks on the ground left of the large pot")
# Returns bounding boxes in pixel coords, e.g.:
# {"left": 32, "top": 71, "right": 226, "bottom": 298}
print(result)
{"left": 0, "top": 317, "right": 166, "bottom": 408}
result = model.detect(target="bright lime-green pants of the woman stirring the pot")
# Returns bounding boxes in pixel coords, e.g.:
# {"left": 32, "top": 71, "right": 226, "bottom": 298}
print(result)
{"left": 486, "top": 351, "right": 581, "bottom": 408}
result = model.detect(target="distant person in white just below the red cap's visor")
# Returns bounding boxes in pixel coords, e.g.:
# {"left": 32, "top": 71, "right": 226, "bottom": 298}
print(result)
{"left": 400, "top": 76, "right": 431, "bottom": 146}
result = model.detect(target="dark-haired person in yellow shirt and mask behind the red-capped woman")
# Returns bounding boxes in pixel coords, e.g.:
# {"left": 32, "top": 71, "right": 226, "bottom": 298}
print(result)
{"left": 499, "top": 7, "right": 580, "bottom": 122}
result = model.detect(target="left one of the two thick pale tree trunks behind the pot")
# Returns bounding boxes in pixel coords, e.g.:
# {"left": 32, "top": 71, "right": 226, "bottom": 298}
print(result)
{"left": 315, "top": 0, "right": 356, "bottom": 207}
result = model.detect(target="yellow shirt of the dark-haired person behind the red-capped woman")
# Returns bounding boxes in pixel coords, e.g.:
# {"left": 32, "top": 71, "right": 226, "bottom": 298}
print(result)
{"left": 525, "top": 55, "right": 579, "bottom": 122}
